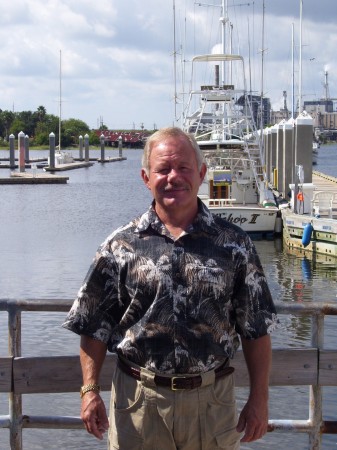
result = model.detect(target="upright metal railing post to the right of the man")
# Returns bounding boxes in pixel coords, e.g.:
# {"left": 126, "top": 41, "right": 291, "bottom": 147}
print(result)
{"left": 309, "top": 314, "right": 324, "bottom": 450}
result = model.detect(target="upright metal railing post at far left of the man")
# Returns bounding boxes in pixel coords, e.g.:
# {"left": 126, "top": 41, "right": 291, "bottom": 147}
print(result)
{"left": 8, "top": 304, "right": 22, "bottom": 450}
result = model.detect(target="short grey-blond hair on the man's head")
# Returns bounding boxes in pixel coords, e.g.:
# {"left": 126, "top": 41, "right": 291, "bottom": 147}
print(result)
{"left": 142, "top": 127, "right": 205, "bottom": 175}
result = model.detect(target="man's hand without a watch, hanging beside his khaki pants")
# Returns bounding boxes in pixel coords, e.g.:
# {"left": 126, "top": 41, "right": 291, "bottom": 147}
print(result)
{"left": 236, "top": 399, "right": 268, "bottom": 442}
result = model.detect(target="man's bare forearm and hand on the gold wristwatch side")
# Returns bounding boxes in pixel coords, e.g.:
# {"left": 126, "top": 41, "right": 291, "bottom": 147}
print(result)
{"left": 80, "top": 335, "right": 109, "bottom": 439}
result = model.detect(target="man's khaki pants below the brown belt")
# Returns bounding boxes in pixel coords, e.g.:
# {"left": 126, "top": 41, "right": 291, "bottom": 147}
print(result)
{"left": 108, "top": 367, "right": 240, "bottom": 450}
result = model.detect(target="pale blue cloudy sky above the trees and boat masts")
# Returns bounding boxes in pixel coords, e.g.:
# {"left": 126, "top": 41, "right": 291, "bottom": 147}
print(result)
{"left": 0, "top": 0, "right": 337, "bottom": 130}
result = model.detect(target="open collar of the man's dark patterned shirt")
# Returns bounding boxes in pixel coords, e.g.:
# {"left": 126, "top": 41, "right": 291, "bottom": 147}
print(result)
{"left": 135, "top": 198, "right": 217, "bottom": 236}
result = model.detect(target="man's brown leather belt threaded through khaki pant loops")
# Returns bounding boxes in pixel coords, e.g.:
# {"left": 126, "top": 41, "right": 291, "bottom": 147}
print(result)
{"left": 118, "top": 358, "right": 234, "bottom": 391}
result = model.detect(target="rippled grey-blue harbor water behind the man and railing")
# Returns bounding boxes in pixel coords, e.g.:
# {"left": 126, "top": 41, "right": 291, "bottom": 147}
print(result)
{"left": 0, "top": 146, "right": 337, "bottom": 450}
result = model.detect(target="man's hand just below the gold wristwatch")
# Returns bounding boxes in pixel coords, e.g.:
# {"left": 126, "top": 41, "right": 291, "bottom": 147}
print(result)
{"left": 81, "top": 391, "right": 109, "bottom": 440}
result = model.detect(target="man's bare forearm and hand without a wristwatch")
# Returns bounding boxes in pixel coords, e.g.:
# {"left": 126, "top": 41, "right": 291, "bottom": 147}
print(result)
{"left": 237, "top": 335, "right": 271, "bottom": 442}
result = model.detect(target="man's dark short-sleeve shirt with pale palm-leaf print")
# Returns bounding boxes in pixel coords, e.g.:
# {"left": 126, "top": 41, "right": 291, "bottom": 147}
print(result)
{"left": 63, "top": 202, "right": 278, "bottom": 373}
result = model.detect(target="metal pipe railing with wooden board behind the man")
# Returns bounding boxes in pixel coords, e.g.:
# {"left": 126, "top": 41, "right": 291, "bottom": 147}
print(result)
{"left": 0, "top": 299, "right": 337, "bottom": 450}
